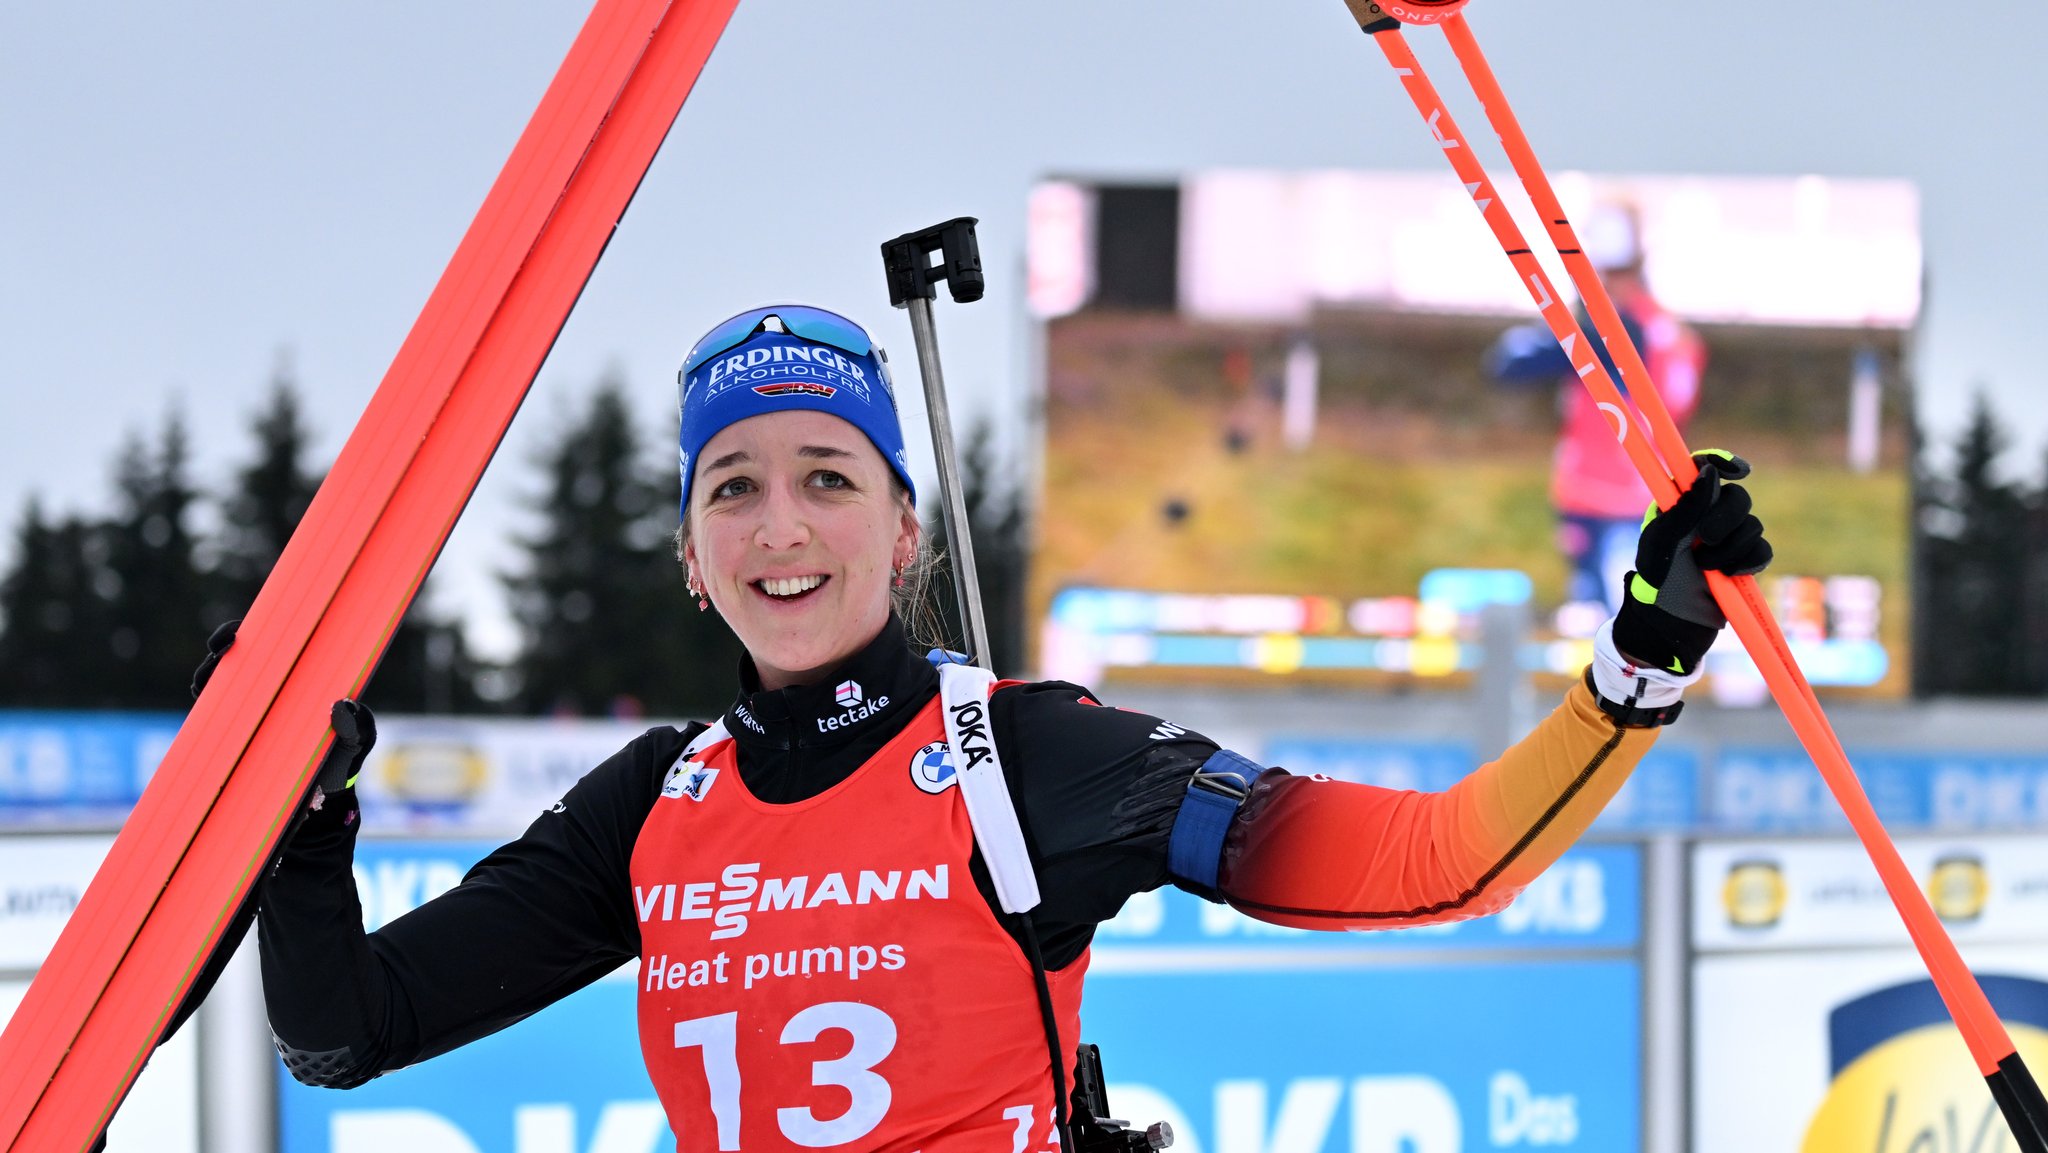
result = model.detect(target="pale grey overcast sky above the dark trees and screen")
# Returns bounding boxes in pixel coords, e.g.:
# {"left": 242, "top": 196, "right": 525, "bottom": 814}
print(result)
{"left": 0, "top": 0, "right": 2048, "bottom": 653}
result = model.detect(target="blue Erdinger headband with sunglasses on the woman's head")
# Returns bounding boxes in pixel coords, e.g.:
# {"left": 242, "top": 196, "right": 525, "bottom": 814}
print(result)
{"left": 676, "top": 305, "right": 918, "bottom": 516}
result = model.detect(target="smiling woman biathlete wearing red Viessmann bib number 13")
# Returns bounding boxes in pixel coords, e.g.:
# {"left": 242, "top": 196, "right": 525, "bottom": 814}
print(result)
{"left": 260, "top": 305, "right": 1769, "bottom": 1153}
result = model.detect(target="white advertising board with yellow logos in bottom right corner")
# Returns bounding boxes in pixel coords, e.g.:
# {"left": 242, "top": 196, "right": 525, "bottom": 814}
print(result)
{"left": 1692, "top": 836, "right": 2048, "bottom": 1153}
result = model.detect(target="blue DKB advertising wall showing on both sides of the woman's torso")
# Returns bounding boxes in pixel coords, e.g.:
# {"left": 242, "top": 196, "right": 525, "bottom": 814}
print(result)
{"left": 279, "top": 842, "right": 1640, "bottom": 1153}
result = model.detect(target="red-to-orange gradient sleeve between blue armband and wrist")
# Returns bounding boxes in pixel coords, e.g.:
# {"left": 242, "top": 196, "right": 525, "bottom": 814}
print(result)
{"left": 1219, "top": 682, "right": 1657, "bottom": 930}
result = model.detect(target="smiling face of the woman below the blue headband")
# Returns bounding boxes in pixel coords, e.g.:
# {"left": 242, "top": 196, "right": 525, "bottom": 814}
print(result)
{"left": 684, "top": 410, "right": 918, "bottom": 688}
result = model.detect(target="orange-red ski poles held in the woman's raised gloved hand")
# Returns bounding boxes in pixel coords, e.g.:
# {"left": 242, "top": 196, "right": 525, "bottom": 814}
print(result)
{"left": 1348, "top": 0, "right": 2048, "bottom": 1153}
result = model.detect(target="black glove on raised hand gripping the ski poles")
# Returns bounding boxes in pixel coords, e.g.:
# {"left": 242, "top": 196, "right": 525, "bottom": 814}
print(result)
{"left": 1614, "top": 449, "right": 1772, "bottom": 676}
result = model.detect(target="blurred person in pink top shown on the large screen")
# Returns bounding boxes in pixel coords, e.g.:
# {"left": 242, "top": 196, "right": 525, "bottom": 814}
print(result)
{"left": 1485, "top": 205, "right": 1706, "bottom": 610}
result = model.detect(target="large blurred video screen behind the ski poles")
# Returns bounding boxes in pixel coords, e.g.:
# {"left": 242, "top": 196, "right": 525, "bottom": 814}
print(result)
{"left": 1030, "top": 172, "right": 1921, "bottom": 700}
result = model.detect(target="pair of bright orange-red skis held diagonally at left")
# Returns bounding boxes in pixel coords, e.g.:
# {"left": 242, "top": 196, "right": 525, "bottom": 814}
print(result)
{"left": 0, "top": 0, "right": 737, "bottom": 1153}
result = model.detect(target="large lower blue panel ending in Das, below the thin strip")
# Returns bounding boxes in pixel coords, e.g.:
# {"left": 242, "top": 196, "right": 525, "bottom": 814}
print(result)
{"left": 1083, "top": 960, "right": 1642, "bottom": 1153}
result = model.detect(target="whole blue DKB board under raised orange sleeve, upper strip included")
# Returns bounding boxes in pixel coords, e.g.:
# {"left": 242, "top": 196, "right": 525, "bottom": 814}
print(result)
{"left": 1083, "top": 846, "right": 1642, "bottom": 1153}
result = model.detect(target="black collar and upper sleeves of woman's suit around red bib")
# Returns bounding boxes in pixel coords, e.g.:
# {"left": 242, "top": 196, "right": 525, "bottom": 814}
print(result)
{"left": 258, "top": 621, "right": 1217, "bottom": 1087}
